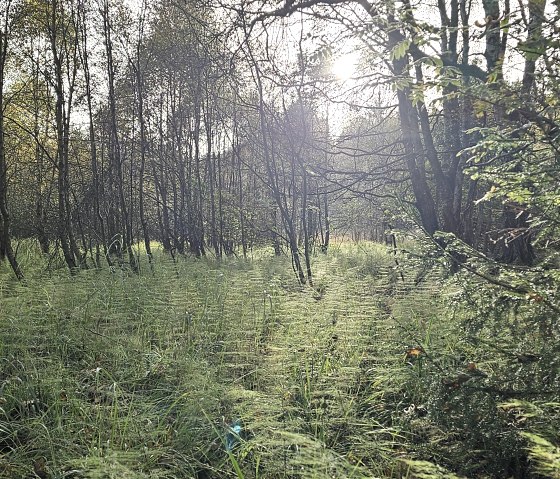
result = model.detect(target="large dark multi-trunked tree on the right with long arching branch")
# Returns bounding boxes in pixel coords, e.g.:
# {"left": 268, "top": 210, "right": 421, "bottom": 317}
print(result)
{"left": 231, "top": 0, "right": 555, "bottom": 268}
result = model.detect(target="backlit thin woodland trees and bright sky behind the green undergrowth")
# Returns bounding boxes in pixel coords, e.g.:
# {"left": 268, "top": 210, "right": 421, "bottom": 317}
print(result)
{"left": 0, "top": 0, "right": 560, "bottom": 477}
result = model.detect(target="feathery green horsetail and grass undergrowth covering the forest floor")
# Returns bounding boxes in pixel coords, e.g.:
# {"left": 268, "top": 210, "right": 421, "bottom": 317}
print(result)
{"left": 0, "top": 243, "right": 559, "bottom": 479}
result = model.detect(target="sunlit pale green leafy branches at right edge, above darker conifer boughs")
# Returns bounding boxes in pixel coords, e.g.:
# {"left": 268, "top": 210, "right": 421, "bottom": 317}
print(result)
{"left": 467, "top": 122, "right": 560, "bottom": 256}
